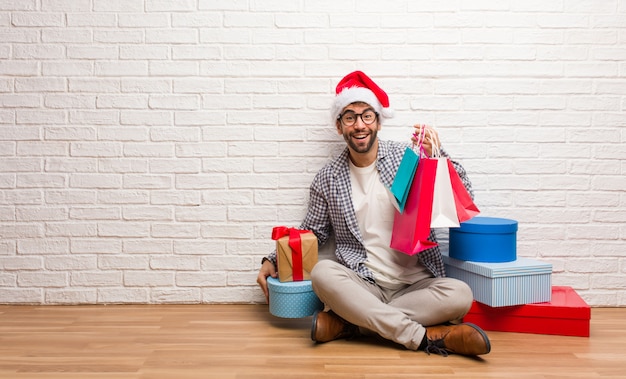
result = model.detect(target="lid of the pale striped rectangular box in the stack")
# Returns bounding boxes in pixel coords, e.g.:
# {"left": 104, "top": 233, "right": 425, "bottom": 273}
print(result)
{"left": 442, "top": 255, "right": 552, "bottom": 278}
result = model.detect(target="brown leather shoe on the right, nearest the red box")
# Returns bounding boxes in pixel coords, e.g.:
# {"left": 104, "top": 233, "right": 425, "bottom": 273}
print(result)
{"left": 425, "top": 323, "right": 491, "bottom": 356}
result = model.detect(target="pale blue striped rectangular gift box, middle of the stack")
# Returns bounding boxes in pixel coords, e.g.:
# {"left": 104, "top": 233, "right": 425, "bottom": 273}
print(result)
{"left": 443, "top": 255, "right": 552, "bottom": 307}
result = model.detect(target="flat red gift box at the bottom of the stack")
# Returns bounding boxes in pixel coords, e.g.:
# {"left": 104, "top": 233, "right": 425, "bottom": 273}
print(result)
{"left": 463, "top": 286, "right": 591, "bottom": 337}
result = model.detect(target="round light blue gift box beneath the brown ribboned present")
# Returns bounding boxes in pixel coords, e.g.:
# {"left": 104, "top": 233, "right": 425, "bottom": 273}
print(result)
{"left": 267, "top": 276, "right": 324, "bottom": 318}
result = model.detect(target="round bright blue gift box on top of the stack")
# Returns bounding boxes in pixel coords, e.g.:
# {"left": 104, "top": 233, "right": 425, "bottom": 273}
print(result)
{"left": 450, "top": 217, "right": 517, "bottom": 263}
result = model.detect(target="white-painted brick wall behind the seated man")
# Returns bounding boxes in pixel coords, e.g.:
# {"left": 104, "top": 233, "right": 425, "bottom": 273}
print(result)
{"left": 0, "top": 0, "right": 626, "bottom": 306}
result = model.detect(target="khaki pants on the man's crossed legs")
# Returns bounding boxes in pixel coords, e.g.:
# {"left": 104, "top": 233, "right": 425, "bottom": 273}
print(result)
{"left": 311, "top": 260, "right": 473, "bottom": 350}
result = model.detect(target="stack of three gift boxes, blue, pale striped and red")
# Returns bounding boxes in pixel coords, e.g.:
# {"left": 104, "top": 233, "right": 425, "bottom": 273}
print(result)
{"left": 443, "top": 217, "right": 591, "bottom": 337}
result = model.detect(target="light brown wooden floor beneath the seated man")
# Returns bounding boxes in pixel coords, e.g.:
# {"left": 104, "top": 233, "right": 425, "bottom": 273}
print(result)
{"left": 0, "top": 305, "right": 626, "bottom": 379}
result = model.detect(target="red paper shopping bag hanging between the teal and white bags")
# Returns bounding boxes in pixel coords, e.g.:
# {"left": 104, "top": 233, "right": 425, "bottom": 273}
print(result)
{"left": 389, "top": 158, "right": 437, "bottom": 255}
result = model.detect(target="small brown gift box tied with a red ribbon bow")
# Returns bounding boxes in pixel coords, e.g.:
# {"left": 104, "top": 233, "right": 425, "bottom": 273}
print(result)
{"left": 272, "top": 226, "right": 318, "bottom": 282}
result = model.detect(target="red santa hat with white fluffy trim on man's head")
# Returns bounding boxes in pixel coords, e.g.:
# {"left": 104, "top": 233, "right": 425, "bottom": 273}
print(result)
{"left": 331, "top": 71, "right": 394, "bottom": 121}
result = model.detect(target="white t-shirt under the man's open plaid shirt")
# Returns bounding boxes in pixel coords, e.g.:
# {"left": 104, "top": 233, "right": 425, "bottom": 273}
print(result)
{"left": 350, "top": 162, "right": 431, "bottom": 290}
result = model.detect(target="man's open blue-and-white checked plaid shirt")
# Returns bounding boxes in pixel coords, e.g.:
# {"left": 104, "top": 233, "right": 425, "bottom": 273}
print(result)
{"left": 268, "top": 140, "right": 473, "bottom": 282}
